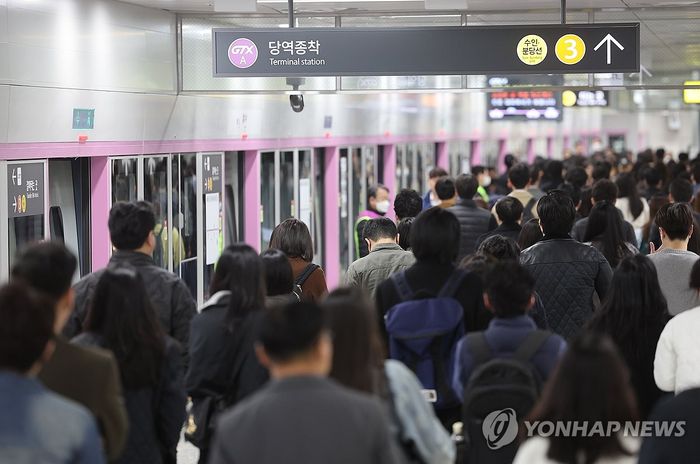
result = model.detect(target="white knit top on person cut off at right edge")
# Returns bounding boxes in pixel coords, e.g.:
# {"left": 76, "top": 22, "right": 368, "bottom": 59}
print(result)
{"left": 654, "top": 306, "right": 700, "bottom": 394}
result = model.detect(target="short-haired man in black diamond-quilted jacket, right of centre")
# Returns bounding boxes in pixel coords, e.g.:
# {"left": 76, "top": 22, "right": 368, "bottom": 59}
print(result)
{"left": 520, "top": 190, "right": 613, "bottom": 339}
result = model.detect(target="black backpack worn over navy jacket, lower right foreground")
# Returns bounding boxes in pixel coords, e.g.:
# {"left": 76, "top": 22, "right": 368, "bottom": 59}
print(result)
{"left": 462, "top": 330, "right": 552, "bottom": 464}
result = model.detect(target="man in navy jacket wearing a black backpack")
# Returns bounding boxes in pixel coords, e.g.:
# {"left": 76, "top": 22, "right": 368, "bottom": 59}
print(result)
{"left": 452, "top": 260, "right": 566, "bottom": 463}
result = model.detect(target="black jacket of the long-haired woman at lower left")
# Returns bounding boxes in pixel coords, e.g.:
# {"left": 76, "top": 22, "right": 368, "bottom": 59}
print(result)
{"left": 73, "top": 332, "right": 187, "bottom": 464}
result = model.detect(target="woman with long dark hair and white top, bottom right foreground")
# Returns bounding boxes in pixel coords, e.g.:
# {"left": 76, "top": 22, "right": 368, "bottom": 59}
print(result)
{"left": 513, "top": 332, "right": 639, "bottom": 464}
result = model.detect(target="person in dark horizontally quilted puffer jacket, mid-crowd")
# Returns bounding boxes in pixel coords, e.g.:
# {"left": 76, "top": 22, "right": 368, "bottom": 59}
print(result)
{"left": 447, "top": 174, "right": 491, "bottom": 263}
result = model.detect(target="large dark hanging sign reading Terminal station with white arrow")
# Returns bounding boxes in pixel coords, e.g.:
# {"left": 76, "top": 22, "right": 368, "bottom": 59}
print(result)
{"left": 212, "top": 23, "right": 639, "bottom": 77}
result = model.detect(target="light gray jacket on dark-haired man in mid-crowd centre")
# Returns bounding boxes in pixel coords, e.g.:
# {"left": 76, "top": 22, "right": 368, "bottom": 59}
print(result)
{"left": 345, "top": 243, "right": 416, "bottom": 299}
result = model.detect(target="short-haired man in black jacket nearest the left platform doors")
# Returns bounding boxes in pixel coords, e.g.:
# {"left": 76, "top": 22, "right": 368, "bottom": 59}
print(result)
{"left": 63, "top": 201, "right": 197, "bottom": 370}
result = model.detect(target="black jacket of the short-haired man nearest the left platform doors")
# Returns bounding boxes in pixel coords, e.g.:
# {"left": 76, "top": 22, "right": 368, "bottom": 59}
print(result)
{"left": 63, "top": 251, "right": 197, "bottom": 369}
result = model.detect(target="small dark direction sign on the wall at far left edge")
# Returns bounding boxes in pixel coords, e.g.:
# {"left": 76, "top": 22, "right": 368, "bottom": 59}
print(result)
{"left": 7, "top": 163, "right": 44, "bottom": 218}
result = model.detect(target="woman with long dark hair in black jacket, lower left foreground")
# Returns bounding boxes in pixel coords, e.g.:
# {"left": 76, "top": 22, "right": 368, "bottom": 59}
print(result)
{"left": 73, "top": 263, "right": 187, "bottom": 464}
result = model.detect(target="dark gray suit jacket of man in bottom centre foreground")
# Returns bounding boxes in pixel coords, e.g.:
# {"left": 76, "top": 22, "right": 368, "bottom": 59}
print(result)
{"left": 209, "top": 376, "right": 400, "bottom": 464}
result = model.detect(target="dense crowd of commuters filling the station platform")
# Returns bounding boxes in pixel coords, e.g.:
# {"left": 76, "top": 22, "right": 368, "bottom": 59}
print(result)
{"left": 0, "top": 149, "right": 700, "bottom": 464}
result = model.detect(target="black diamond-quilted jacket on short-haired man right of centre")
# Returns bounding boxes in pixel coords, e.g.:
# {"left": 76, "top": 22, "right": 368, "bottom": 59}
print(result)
{"left": 520, "top": 236, "right": 613, "bottom": 340}
